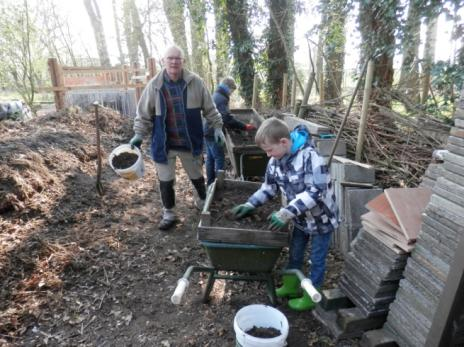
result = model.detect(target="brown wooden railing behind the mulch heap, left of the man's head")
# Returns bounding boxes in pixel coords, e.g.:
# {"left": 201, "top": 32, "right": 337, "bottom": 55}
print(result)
{"left": 46, "top": 58, "right": 156, "bottom": 110}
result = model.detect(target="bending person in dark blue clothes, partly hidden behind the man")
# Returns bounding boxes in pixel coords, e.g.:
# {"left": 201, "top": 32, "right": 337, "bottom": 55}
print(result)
{"left": 205, "top": 77, "right": 256, "bottom": 185}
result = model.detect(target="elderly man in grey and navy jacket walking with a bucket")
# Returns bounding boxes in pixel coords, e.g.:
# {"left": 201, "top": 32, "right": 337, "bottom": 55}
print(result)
{"left": 130, "top": 46, "right": 224, "bottom": 230}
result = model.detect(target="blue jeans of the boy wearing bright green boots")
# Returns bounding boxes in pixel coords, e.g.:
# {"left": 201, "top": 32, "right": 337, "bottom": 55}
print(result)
{"left": 287, "top": 228, "right": 332, "bottom": 288}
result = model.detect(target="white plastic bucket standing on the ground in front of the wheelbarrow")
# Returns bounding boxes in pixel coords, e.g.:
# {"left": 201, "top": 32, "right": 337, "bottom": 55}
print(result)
{"left": 234, "top": 305, "right": 288, "bottom": 347}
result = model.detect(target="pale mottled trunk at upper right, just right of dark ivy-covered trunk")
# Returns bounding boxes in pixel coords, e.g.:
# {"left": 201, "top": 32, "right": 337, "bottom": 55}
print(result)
{"left": 399, "top": 0, "right": 420, "bottom": 101}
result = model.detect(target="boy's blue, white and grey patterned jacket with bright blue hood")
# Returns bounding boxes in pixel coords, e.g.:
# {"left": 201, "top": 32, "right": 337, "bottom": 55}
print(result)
{"left": 248, "top": 125, "right": 339, "bottom": 234}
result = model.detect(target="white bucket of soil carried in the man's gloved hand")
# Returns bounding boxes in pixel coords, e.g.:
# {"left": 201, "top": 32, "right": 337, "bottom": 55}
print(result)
{"left": 108, "top": 144, "right": 145, "bottom": 180}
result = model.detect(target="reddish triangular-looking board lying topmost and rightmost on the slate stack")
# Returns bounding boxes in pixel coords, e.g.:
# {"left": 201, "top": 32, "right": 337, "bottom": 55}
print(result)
{"left": 385, "top": 187, "right": 432, "bottom": 241}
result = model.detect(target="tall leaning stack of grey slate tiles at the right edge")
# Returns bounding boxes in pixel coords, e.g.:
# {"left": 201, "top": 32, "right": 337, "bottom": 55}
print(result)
{"left": 383, "top": 99, "right": 464, "bottom": 346}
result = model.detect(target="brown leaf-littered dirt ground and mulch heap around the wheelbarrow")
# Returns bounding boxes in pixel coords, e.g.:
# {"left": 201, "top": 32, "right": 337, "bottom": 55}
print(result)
{"left": 0, "top": 109, "right": 357, "bottom": 347}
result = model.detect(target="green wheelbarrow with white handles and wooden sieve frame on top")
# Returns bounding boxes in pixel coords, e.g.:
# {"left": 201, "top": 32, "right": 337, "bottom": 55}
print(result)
{"left": 171, "top": 175, "right": 321, "bottom": 305}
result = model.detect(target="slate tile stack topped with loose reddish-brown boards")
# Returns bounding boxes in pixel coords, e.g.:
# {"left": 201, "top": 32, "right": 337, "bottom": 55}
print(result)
{"left": 339, "top": 188, "right": 431, "bottom": 317}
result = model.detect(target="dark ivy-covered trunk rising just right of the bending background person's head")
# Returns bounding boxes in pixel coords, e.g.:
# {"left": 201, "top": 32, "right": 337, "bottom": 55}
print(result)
{"left": 226, "top": 0, "right": 255, "bottom": 105}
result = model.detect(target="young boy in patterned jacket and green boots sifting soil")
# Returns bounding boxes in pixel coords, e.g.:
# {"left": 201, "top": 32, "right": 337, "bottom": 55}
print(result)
{"left": 232, "top": 117, "right": 338, "bottom": 311}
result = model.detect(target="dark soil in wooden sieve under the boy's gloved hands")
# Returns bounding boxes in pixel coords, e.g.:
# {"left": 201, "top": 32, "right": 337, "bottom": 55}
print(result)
{"left": 209, "top": 185, "right": 280, "bottom": 230}
